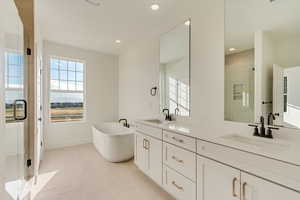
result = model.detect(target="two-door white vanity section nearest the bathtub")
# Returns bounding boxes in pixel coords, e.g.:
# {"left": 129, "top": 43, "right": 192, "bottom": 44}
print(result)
{"left": 135, "top": 125, "right": 162, "bottom": 185}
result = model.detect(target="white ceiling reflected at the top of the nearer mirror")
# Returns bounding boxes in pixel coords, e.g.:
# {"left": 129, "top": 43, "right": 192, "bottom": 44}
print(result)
{"left": 225, "top": 0, "right": 300, "bottom": 51}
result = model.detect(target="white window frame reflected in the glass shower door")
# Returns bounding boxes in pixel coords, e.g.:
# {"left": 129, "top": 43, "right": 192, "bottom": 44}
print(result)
{"left": 3, "top": 48, "right": 26, "bottom": 124}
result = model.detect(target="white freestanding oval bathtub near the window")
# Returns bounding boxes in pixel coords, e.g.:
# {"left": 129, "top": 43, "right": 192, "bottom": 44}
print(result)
{"left": 93, "top": 122, "right": 134, "bottom": 162}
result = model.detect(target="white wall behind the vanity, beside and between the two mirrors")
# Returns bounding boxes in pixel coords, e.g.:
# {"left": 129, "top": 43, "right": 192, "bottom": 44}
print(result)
{"left": 119, "top": 0, "right": 300, "bottom": 138}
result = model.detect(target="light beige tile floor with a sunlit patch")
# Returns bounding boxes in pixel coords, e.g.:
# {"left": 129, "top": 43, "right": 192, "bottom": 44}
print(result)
{"left": 33, "top": 144, "right": 174, "bottom": 200}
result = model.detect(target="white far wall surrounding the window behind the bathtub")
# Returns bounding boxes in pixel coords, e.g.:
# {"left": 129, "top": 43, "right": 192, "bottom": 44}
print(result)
{"left": 43, "top": 41, "right": 118, "bottom": 149}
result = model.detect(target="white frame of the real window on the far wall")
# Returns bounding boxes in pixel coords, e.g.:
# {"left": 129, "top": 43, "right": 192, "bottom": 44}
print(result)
{"left": 47, "top": 55, "right": 87, "bottom": 124}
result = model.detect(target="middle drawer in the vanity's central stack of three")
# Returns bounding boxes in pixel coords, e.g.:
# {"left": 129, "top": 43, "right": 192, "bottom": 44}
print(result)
{"left": 163, "top": 142, "right": 196, "bottom": 181}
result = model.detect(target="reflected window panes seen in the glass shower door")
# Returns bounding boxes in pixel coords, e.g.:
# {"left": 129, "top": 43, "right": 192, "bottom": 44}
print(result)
{"left": 5, "top": 51, "right": 24, "bottom": 123}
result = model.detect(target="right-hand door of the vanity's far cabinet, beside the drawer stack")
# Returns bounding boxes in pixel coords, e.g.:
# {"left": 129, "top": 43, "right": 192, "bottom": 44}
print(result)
{"left": 146, "top": 137, "right": 162, "bottom": 185}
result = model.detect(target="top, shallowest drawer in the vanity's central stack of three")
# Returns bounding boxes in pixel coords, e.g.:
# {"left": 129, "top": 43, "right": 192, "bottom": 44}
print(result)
{"left": 163, "top": 131, "right": 196, "bottom": 152}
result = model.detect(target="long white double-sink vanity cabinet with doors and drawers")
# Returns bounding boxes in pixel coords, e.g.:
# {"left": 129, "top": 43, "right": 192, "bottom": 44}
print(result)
{"left": 135, "top": 124, "right": 300, "bottom": 200}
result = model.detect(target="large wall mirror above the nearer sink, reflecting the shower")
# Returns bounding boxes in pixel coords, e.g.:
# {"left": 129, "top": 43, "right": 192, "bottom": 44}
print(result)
{"left": 224, "top": 0, "right": 300, "bottom": 128}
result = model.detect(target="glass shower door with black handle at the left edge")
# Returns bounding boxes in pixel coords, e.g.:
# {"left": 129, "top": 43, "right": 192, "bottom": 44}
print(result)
{"left": 0, "top": 0, "right": 27, "bottom": 200}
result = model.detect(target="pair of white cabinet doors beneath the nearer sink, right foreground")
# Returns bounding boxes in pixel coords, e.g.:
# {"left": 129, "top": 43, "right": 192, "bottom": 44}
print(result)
{"left": 197, "top": 147, "right": 300, "bottom": 200}
